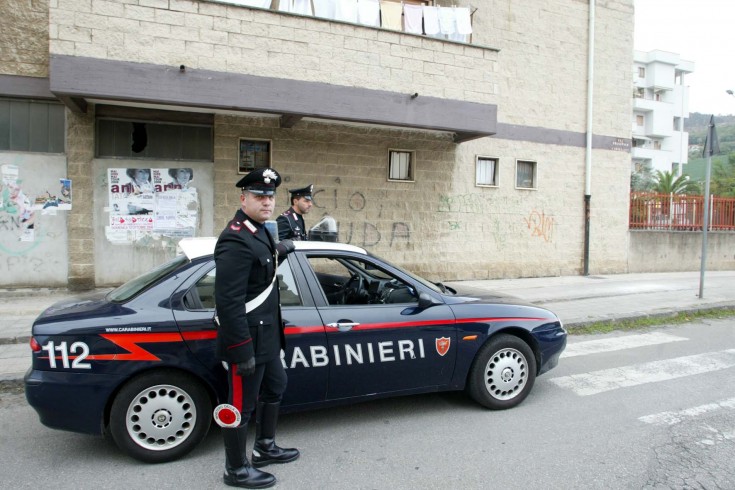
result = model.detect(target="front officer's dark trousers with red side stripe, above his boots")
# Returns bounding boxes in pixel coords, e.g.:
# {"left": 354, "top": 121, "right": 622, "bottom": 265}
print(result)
{"left": 228, "top": 357, "right": 288, "bottom": 427}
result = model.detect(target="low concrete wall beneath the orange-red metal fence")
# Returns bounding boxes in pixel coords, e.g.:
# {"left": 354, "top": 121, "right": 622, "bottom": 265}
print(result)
{"left": 628, "top": 231, "right": 735, "bottom": 272}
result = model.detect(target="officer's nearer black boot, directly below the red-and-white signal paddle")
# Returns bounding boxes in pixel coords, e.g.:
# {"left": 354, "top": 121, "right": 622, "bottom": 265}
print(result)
{"left": 222, "top": 425, "right": 276, "bottom": 488}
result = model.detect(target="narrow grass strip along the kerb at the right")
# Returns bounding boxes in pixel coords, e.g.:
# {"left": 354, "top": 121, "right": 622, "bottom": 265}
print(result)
{"left": 567, "top": 308, "right": 735, "bottom": 335}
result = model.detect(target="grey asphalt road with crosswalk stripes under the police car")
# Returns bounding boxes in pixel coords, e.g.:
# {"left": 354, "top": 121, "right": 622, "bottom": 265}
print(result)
{"left": 0, "top": 318, "right": 735, "bottom": 490}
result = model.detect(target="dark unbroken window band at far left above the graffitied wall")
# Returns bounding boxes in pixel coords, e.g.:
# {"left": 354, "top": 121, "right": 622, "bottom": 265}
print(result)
{"left": 0, "top": 99, "right": 65, "bottom": 153}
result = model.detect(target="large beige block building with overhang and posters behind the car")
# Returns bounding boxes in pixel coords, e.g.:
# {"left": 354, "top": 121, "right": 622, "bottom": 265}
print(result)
{"left": 0, "top": 0, "right": 632, "bottom": 289}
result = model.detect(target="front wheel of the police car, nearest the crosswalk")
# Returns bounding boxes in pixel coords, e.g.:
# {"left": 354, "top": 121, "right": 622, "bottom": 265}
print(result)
{"left": 468, "top": 334, "right": 536, "bottom": 410}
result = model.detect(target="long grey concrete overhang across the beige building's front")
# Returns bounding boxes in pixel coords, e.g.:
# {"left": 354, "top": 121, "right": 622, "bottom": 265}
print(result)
{"left": 50, "top": 55, "right": 497, "bottom": 143}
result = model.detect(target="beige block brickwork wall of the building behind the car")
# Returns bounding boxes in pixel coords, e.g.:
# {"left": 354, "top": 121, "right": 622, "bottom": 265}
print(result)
{"left": 0, "top": 0, "right": 648, "bottom": 287}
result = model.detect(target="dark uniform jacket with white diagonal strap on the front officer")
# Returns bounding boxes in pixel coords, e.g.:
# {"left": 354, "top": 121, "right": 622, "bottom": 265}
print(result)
{"left": 214, "top": 209, "right": 286, "bottom": 364}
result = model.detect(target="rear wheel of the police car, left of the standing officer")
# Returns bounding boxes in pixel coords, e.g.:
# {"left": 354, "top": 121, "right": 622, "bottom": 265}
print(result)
{"left": 110, "top": 371, "right": 212, "bottom": 463}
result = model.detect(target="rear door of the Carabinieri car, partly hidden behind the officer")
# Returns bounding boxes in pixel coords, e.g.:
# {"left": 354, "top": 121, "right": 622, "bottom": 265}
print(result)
{"left": 172, "top": 255, "right": 328, "bottom": 407}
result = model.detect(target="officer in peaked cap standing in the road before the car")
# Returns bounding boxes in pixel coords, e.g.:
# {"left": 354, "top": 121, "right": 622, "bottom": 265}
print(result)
{"left": 214, "top": 168, "right": 299, "bottom": 488}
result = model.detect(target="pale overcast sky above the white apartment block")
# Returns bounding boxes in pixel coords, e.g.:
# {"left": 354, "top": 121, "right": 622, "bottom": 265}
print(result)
{"left": 635, "top": 0, "right": 735, "bottom": 115}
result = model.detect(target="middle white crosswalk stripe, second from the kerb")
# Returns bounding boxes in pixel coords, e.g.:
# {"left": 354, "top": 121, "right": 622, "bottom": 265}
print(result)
{"left": 549, "top": 349, "right": 735, "bottom": 396}
